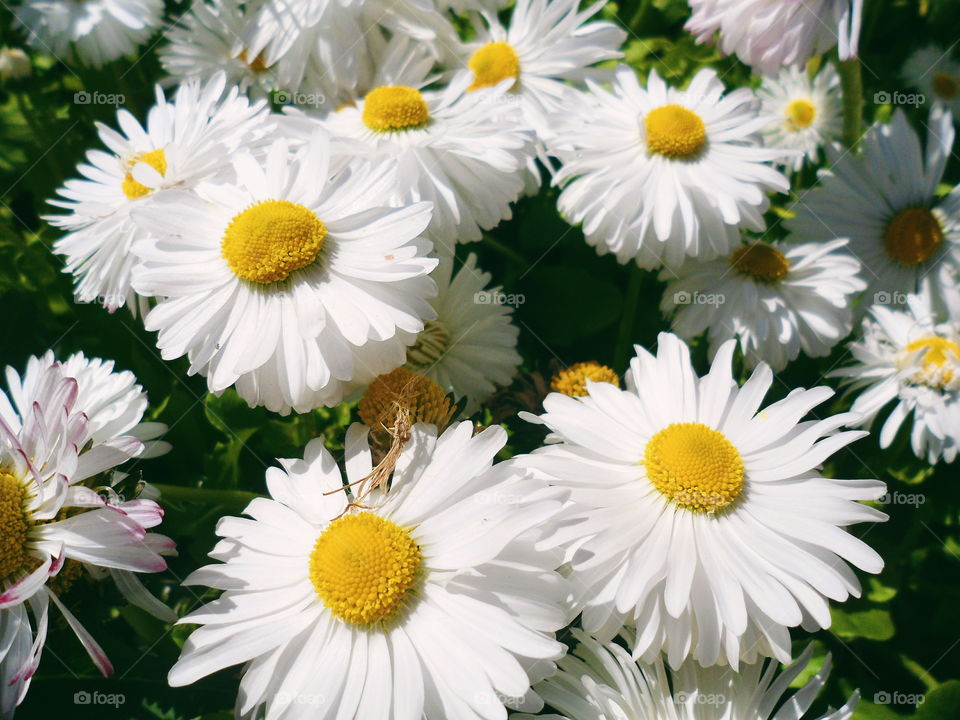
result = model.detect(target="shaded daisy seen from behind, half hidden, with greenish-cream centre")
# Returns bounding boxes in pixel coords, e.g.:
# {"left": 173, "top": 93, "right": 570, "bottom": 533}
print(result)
{"left": 406, "top": 253, "right": 521, "bottom": 415}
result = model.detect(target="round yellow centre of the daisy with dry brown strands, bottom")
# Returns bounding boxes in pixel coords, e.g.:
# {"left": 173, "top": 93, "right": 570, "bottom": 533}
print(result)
{"left": 310, "top": 512, "right": 423, "bottom": 626}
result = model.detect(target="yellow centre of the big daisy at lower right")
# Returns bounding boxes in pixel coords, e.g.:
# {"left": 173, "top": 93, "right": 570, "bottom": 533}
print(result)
{"left": 643, "top": 423, "right": 744, "bottom": 514}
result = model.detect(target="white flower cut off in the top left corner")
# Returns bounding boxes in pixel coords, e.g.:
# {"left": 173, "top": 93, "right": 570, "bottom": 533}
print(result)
{"left": 13, "top": 0, "right": 163, "bottom": 68}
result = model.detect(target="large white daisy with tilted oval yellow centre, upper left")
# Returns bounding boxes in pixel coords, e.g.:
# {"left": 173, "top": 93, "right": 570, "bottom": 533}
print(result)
{"left": 133, "top": 134, "right": 437, "bottom": 413}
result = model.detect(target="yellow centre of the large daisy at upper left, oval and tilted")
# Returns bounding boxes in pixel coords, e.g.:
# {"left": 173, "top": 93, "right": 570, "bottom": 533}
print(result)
{"left": 220, "top": 200, "right": 327, "bottom": 284}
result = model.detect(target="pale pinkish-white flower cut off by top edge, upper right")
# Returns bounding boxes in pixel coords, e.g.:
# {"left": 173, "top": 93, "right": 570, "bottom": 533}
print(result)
{"left": 684, "top": 0, "right": 863, "bottom": 75}
